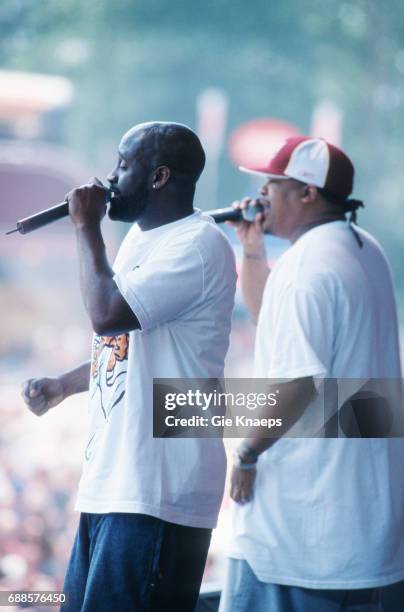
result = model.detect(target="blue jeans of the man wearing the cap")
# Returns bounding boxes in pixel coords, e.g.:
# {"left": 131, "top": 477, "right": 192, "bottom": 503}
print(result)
{"left": 219, "top": 559, "right": 383, "bottom": 612}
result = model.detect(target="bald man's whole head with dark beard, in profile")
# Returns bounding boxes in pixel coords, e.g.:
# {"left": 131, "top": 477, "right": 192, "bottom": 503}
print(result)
{"left": 108, "top": 121, "right": 205, "bottom": 229}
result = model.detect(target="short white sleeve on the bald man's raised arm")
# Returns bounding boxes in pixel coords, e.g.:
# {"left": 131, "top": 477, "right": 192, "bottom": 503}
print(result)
{"left": 114, "top": 241, "right": 204, "bottom": 331}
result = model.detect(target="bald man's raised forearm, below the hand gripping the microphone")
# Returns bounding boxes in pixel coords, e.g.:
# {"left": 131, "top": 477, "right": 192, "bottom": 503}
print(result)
{"left": 76, "top": 224, "right": 117, "bottom": 333}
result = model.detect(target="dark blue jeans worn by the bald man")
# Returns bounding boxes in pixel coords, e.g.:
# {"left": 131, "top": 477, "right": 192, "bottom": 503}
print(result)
{"left": 61, "top": 512, "right": 211, "bottom": 612}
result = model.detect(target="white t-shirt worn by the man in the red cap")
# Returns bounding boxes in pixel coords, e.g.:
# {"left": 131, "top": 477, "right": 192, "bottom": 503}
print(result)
{"left": 230, "top": 221, "right": 404, "bottom": 589}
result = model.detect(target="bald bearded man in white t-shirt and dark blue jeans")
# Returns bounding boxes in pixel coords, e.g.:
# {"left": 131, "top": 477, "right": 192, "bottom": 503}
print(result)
{"left": 23, "top": 122, "right": 236, "bottom": 612}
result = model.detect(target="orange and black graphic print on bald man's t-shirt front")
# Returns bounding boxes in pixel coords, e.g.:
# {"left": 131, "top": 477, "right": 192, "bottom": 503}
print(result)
{"left": 85, "top": 334, "right": 129, "bottom": 460}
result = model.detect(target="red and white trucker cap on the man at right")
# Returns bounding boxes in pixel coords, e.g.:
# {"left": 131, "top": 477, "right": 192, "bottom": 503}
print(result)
{"left": 239, "top": 136, "right": 354, "bottom": 200}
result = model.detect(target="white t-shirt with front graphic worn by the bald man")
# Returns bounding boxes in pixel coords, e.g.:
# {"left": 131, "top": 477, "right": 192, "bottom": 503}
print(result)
{"left": 76, "top": 211, "right": 236, "bottom": 528}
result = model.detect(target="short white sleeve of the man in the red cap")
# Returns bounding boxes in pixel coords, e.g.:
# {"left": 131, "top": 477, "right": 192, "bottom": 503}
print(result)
{"left": 268, "top": 283, "right": 335, "bottom": 378}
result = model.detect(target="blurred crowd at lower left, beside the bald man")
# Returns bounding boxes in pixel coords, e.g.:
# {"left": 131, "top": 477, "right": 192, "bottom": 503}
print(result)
{"left": 0, "top": 381, "right": 85, "bottom": 608}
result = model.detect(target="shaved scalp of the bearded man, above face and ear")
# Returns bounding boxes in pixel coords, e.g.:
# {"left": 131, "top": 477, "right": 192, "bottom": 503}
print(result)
{"left": 120, "top": 121, "right": 205, "bottom": 185}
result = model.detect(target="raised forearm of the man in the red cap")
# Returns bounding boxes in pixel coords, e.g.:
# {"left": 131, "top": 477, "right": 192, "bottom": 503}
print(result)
{"left": 241, "top": 246, "right": 270, "bottom": 322}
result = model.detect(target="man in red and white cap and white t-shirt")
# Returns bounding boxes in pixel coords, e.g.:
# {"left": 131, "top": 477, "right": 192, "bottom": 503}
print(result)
{"left": 220, "top": 137, "right": 404, "bottom": 612}
